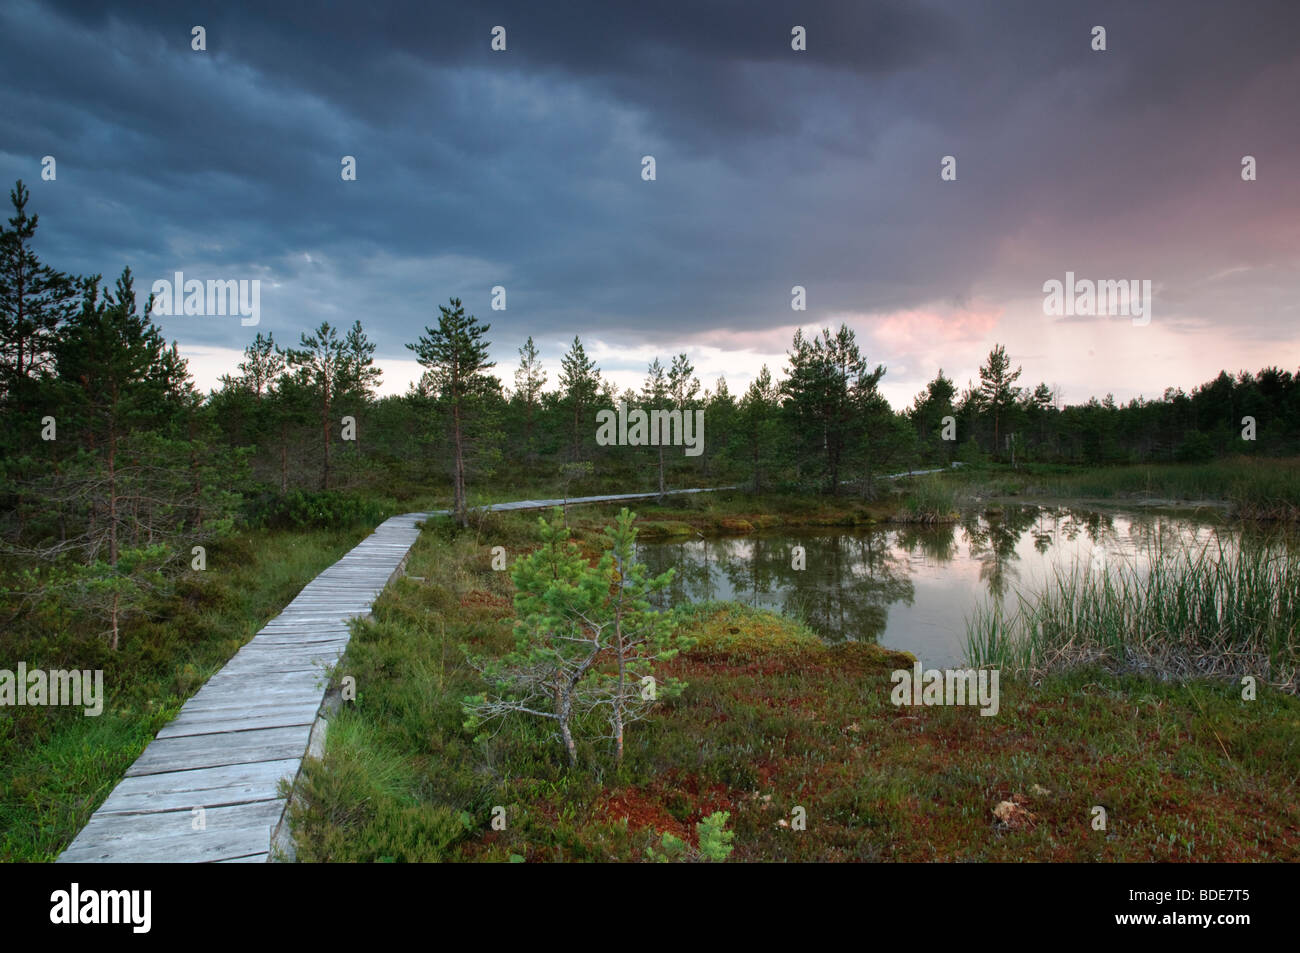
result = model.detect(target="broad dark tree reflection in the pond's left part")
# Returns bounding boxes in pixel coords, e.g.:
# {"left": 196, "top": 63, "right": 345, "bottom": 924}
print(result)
{"left": 640, "top": 532, "right": 914, "bottom": 641}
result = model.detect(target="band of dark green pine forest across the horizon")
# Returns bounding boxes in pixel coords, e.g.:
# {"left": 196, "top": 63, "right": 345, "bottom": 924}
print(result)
{"left": 0, "top": 172, "right": 1300, "bottom": 639}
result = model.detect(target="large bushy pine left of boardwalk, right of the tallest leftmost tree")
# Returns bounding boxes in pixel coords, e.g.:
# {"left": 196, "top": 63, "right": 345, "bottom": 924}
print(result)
{"left": 26, "top": 269, "right": 235, "bottom": 650}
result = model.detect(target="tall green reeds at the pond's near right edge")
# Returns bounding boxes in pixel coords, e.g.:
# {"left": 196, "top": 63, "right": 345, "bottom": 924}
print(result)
{"left": 966, "top": 542, "right": 1300, "bottom": 694}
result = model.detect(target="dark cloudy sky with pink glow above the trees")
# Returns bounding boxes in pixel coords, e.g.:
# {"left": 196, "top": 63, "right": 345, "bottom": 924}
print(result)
{"left": 0, "top": 0, "right": 1300, "bottom": 406}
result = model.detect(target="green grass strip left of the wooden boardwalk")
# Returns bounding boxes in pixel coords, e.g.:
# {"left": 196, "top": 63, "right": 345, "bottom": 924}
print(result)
{"left": 0, "top": 529, "right": 364, "bottom": 861}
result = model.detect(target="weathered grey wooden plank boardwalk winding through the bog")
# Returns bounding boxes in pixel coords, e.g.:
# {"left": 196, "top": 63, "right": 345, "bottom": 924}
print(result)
{"left": 59, "top": 471, "right": 956, "bottom": 863}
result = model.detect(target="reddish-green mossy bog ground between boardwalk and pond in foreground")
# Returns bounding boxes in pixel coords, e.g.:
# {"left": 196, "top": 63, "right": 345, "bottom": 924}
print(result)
{"left": 293, "top": 517, "right": 1300, "bottom": 862}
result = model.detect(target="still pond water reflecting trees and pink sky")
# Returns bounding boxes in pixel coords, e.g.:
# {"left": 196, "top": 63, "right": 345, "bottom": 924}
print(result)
{"left": 638, "top": 506, "right": 1238, "bottom": 667}
